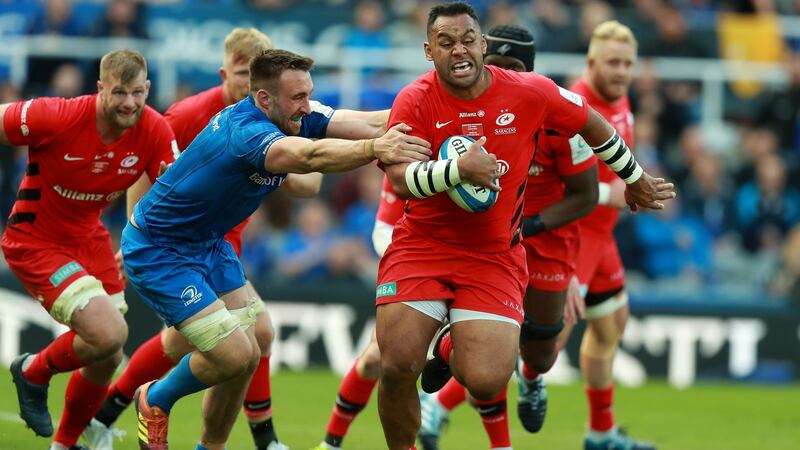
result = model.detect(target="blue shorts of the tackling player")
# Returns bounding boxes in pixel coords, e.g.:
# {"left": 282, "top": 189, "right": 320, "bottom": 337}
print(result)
{"left": 120, "top": 222, "right": 245, "bottom": 326}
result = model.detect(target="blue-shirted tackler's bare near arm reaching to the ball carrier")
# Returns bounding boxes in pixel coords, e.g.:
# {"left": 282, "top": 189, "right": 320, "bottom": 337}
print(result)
{"left": 264, "top": 123, "right": 431, "bottom": 173}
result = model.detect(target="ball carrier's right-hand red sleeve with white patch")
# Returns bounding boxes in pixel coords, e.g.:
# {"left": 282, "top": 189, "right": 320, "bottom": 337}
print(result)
{"left": 539, "top": 77, "right": 589, "bottom": 137}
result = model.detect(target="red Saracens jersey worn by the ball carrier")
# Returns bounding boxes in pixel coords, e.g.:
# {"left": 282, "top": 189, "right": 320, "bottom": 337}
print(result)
{"left": 389, "top": 66, "right": 588, "bottom": 252}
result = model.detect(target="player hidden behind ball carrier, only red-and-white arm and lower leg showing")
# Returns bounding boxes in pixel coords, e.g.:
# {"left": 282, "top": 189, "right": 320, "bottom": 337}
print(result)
{"left": 313, "top": 177, "right": 406, "bottom": 450}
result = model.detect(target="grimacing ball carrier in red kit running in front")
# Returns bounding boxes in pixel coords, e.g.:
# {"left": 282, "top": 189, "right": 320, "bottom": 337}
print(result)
{"left": 376, "top": 2, "right": 674, "bottom": 450}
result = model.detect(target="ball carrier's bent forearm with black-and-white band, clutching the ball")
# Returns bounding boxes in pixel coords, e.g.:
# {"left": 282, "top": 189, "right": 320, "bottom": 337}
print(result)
{"left": 386, "top": 137, "right": 502, "bottom": 199}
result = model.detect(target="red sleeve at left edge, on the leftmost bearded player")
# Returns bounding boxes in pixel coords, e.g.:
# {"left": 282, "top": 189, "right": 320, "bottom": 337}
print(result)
{"left": 3, "top": 97, "right": 70, "bottom": 147}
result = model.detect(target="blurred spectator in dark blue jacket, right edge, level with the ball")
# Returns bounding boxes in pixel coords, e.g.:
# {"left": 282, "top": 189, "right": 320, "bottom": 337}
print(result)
{"left": 736, "top": 154, "right": 800, "bottom": 252}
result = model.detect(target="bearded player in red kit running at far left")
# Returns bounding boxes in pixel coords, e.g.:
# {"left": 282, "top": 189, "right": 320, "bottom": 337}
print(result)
{"left": 0, "top": 50, "right": 177, "bottom": 450}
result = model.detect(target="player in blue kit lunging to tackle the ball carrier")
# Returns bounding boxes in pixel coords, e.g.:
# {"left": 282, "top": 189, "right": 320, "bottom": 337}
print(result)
{"left": 122, "top": 50, "right": 431, "bottom": 450}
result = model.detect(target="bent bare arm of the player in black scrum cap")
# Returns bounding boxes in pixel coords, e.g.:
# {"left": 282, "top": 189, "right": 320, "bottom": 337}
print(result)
{"left": 522, "top": 165, "right": 598, "bottom": 237}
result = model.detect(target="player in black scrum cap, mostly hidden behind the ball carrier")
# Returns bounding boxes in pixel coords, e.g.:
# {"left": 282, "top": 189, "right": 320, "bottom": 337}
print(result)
{"left": 419, "top": 25, "right": 597, "bottom": 450}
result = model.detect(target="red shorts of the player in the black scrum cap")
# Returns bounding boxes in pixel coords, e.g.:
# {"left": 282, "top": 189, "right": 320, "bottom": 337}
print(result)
{"left": 522, "top": 223, "right": 579, "bottom": 292}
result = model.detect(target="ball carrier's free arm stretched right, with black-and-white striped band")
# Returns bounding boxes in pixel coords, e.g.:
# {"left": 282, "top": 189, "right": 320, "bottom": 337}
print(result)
{"left": 579, "top": 107, "right": 675, "bottom": 211}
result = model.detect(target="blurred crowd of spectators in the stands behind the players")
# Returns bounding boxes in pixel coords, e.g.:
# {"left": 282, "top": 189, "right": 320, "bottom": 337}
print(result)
{"left": 0, "top": 0, "right": 800, "bottom": 299}
